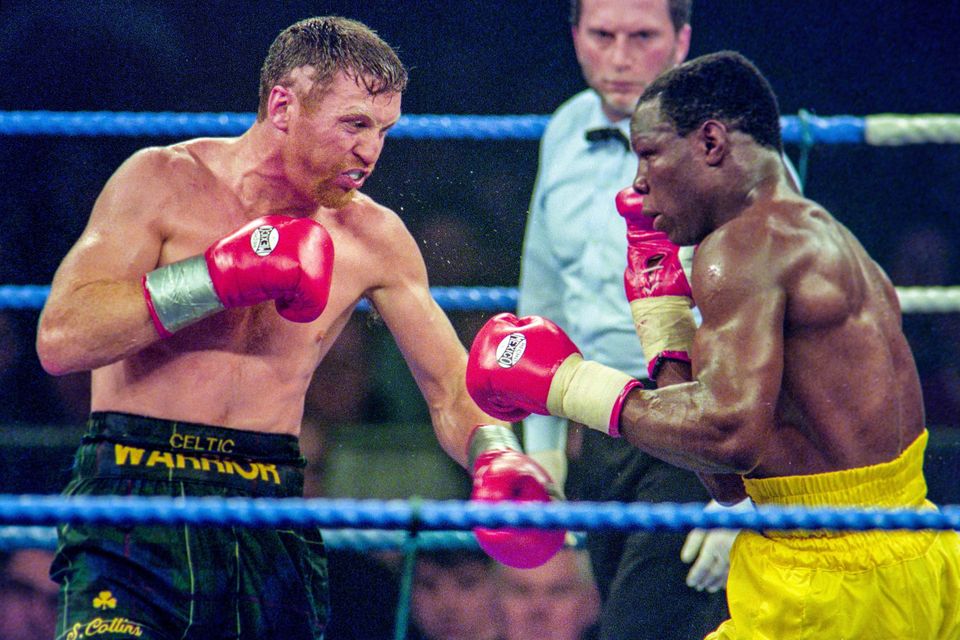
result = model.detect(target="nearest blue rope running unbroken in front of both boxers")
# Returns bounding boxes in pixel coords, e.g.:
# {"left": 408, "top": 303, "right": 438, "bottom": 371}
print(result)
{"left": 0, "top": 495, "right": 960, "bottom": 531}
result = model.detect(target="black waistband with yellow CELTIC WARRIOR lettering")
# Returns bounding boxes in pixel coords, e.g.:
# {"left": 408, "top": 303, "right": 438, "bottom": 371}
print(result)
{"left": 75, "top": 412, "right": 306, "bottom": 497}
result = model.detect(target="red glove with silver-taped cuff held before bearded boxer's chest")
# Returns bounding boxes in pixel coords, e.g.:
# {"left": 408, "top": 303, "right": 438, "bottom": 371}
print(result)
{"left": 143, "top": 215, "right": 333, "bottom": 338}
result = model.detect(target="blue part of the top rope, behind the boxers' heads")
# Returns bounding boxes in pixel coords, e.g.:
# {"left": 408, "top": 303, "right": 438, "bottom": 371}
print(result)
{"left": 0, "top": 111, "right": 866, "bottom": 144}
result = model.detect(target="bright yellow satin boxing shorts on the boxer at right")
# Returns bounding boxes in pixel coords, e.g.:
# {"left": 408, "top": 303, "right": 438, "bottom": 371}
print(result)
{"left": 707, "top": 431, "right": 960, "bottom": 640}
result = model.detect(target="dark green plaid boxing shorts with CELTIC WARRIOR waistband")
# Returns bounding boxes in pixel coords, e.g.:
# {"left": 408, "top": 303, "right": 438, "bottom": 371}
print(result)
{"left": 51, "top": 413, "right": 329, "bottom": 640}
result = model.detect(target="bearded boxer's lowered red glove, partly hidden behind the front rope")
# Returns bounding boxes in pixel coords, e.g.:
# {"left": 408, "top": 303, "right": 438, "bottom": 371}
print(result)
{"left": 468, "top": 425, "right": 566, "bottom": 569}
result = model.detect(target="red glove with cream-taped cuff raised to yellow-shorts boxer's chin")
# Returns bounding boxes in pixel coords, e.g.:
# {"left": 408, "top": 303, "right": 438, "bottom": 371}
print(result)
{"left": 616, "top": 187, "right": 697, "bottom": 379}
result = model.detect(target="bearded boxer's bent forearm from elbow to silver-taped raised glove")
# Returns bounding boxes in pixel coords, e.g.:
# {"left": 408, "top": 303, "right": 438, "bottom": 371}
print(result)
{"left": 37, "top": 280, "right": 159, "bottom": 375}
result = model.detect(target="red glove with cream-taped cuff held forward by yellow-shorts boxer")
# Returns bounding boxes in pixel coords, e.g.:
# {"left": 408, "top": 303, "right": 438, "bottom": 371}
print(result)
{"left": 466, "top": 313, "right": 640, "bottom": 437}
